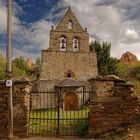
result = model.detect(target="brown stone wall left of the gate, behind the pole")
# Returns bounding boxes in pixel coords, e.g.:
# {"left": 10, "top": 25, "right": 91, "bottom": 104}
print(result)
{"left": 0, "top": 81, "right": 30, "bottom": 138}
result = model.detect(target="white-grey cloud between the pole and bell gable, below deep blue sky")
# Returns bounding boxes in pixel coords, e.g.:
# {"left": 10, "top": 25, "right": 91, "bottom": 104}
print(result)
{"left": 10, "top": 20, "right": 50, "bottom": 59}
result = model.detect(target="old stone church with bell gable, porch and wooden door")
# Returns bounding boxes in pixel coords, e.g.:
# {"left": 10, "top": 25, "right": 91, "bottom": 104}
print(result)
{"left": 32, "top": 7, "right": 98, "bottom": 110}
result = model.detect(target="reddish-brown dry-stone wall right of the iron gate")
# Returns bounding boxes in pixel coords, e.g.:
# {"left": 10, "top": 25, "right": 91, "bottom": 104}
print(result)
{"left": 88, "top": 79, "right": 139, "bottom": 137}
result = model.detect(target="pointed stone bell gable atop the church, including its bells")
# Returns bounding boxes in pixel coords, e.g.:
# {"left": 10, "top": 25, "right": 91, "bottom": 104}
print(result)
{"left": 48, "top": 7, "right": 89, "bottom": 52}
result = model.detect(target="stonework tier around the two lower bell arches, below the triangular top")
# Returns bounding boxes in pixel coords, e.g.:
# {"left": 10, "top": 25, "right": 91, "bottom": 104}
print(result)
{"left": 49, "top": 30, "right": 89, "bottom": 52}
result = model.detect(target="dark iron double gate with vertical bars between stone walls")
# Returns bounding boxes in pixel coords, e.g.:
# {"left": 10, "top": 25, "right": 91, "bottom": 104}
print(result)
{"left": 29, "top": 92, "right": 90, "bottom": 136}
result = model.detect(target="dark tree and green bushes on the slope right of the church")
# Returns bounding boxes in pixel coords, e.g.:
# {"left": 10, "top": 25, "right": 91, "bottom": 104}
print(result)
{"left": 89, "top": 41, "right": 140, "bottom": 95}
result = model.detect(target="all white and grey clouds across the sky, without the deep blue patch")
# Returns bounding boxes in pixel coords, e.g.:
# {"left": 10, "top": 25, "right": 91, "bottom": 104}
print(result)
{"left": 0, "top": 0, "right": 140, "bottom": 58}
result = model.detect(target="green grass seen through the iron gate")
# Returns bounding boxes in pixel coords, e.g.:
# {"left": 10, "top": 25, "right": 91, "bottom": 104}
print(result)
{"left": 29, "top": 107, "right": 89, "bottom": 135}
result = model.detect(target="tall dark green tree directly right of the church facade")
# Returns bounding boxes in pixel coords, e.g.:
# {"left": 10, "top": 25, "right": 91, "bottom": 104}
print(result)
{"left": 89, "top": 41, "right": 118, "bottom": 75}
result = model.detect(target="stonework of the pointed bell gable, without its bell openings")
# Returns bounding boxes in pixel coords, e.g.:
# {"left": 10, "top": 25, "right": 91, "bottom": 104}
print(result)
{"left": 49, "top": 8, "right": 89, "bottom": 52}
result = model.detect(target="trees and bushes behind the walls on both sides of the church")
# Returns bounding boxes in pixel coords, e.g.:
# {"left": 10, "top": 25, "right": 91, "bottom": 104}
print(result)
{"left": 0, "top": 41, "right": 140, "bottom": 91}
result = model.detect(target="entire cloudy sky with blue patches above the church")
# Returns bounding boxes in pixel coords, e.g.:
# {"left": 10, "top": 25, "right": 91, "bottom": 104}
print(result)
{"left": 0, "top": 0, "right": 140, "bottom": 59}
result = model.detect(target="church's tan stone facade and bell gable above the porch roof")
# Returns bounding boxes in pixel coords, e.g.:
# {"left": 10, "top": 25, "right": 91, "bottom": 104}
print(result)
{"left": 40, "top": 7, "right": 98, "bottom": 89}
